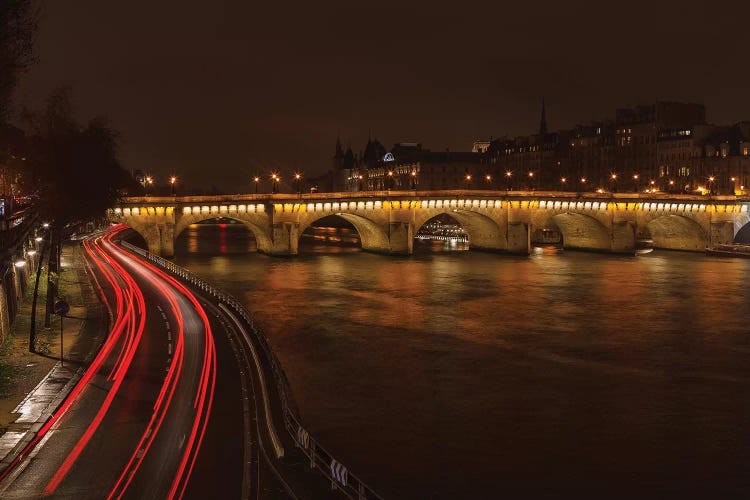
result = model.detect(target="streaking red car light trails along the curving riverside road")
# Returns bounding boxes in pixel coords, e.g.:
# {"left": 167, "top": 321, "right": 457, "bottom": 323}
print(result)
{"left": 0, "top": 226, "right": 216, "bottom": 499}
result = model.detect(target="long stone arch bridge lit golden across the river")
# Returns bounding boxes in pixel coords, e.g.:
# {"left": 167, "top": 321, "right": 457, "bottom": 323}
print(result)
{"left": 109, "top": 191, "right": 750, "bottom": 257}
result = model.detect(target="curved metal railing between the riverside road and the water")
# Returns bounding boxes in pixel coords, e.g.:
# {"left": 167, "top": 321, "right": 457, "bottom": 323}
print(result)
{"left": 121, "top": 241, "right": 382, "bottom": 500}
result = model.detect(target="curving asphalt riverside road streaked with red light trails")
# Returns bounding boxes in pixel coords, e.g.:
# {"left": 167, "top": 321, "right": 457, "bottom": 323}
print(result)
{"left": 0, "top": 226, "right": 350, "bottom": 498}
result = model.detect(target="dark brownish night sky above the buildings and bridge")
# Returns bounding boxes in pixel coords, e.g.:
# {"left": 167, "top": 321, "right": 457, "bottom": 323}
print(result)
{"left": 18, "top": 0, "right": 750, "bottom": 192}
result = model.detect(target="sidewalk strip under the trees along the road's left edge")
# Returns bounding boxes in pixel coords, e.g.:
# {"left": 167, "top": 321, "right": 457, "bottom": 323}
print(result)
{"left": 0, "top": 242, "right": 107, "bottom": 471}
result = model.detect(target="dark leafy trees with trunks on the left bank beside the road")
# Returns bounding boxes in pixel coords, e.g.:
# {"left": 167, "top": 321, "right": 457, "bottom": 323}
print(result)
{"left": 0, "top": 0, "right": 138, "bottom": 351}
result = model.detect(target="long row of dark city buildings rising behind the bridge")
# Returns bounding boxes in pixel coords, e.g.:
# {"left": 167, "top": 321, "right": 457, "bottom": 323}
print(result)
{"left": 318, "top": 101, "right": 750, "bottom": 195}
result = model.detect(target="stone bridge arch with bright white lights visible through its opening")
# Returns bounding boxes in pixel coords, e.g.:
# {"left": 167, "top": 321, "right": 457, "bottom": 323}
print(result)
{"left": 414, "top": 209, "right": 508, "bottom": 250}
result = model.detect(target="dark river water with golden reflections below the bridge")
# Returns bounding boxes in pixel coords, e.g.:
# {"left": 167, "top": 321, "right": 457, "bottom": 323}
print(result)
{"left": 176, "top": 224, "right": 750, "bottom": 499}
